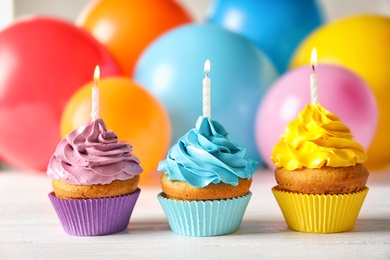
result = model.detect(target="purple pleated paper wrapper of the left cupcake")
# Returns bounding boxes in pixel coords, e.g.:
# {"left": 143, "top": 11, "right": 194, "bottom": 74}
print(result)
{"left": 48, "top": 189, "right": 141, "bottom": 236}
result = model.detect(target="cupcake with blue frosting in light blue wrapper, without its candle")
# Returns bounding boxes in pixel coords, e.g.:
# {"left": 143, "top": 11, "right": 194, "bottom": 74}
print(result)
{"left": 158, "top": 117, "right": 257, "bottom": 236}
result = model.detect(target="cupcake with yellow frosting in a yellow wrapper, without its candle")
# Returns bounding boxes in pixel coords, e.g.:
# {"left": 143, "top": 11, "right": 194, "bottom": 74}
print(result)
{"left": 271, "top": 103, "right": 369, "bottom": 233}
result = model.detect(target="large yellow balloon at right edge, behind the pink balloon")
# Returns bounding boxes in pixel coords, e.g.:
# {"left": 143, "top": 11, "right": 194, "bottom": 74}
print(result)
{"left": 291, "top": 15, "right": 390, "bottom": 169}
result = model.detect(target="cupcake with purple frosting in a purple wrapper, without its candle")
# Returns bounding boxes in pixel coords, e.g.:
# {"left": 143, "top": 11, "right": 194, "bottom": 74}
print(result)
{"left": 47, "top": 118, "right": 142, "bottom": 236}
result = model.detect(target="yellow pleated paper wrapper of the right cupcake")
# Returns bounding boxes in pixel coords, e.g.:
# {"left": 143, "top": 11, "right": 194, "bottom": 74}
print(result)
{"left": 272, "top": 186, "right": 368, "bottom": 233}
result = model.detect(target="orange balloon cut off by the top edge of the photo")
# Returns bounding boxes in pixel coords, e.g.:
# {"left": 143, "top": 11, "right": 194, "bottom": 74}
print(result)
{"left": 76, "top": 0, "right": 193, "bottom": 76}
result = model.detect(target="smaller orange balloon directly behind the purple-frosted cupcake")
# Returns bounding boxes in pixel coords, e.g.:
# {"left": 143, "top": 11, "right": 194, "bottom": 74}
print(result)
{"left": 61, "top": 77, "right": 171, "bottom": 185}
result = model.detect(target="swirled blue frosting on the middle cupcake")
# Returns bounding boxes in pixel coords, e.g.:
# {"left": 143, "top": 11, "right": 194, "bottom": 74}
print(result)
{"left": 158, "top": 117, "right": 258, "bottom": 188}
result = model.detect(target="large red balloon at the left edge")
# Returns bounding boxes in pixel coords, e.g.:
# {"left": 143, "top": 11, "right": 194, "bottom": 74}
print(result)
{"left": 0, "top": 17, "right": 120, "bottom": 171}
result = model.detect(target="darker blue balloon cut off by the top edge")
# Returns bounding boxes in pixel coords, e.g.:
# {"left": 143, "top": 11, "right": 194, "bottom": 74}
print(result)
{"left": 206, "top": 0, "right": 324, "bottom": 73}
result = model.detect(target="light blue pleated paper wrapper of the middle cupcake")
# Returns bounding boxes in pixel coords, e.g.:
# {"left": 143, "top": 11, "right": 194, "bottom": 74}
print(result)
{"left": 157, "top": 192, "right": 252, "bottom": 237}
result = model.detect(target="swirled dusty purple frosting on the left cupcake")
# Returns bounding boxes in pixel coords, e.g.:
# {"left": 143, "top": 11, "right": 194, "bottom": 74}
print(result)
{"left": 46, "top": 118, "right": 142, "bottom": 185}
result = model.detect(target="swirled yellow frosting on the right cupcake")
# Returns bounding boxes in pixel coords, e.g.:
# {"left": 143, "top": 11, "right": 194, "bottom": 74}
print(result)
{"left": 271, "top": 104, "right": 367, "bottom": 171}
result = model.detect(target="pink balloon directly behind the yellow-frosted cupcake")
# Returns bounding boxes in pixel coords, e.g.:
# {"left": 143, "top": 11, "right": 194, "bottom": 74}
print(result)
{"left": 255, "top": 64, "right": 378, "bottom": 169}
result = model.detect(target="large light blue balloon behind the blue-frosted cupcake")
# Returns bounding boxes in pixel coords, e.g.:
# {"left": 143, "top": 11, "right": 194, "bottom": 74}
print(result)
{"left": 135, "top": 25, "right": 277, "bottom": 164}
